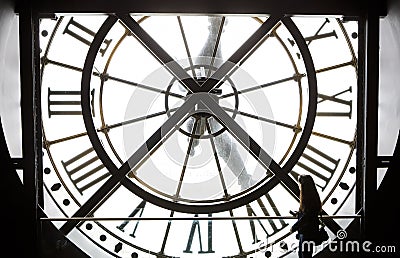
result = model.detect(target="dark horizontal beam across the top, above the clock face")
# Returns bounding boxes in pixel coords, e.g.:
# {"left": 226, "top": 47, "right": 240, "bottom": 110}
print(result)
{"left": 16, "top": 0, "right": 386, "bottom": 16}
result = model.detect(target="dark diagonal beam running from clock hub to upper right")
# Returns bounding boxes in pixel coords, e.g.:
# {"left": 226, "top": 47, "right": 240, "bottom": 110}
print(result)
{"left": 201, "top": 14, "right": 284, "bottom": 92}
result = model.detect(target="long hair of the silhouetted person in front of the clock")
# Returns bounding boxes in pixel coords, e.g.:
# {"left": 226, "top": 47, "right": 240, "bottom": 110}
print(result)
{"left": 298, "top": 175, "right": 322, "bottom": 213}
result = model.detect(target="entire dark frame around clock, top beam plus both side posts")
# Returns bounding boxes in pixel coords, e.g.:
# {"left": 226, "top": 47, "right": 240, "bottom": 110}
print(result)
{"left": 15, "top": 0, "right": 386, "bottom": 254}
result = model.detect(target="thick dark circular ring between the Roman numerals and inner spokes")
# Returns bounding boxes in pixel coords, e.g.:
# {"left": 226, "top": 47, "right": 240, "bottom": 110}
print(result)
{"left": 81, "top": 15, "right": 317, "bottom": 214}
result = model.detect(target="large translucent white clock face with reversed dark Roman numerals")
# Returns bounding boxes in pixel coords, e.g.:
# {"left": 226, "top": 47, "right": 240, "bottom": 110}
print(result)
{"left": 40, "top": 14, "right": 357, "bottom": 257}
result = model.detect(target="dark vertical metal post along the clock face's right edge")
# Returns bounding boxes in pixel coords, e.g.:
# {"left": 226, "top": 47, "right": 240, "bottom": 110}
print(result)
{"left": 358, "top": 8, "right": 380, "bottom": 239}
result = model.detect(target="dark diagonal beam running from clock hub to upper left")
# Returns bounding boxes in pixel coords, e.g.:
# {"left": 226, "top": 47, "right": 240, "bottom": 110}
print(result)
{"left": 117, "top": 14, "right": 200, "bottom": 93}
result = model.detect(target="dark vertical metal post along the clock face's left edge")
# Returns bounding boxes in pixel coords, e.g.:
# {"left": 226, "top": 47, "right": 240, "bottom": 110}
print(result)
{"left": 19, "top": 1, "right": 43, "bottom": 255}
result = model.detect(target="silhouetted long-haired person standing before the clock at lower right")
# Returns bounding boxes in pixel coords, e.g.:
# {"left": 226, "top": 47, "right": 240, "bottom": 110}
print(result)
{"left": 290, "top": 175, "right": 322, "bottom": 258}
